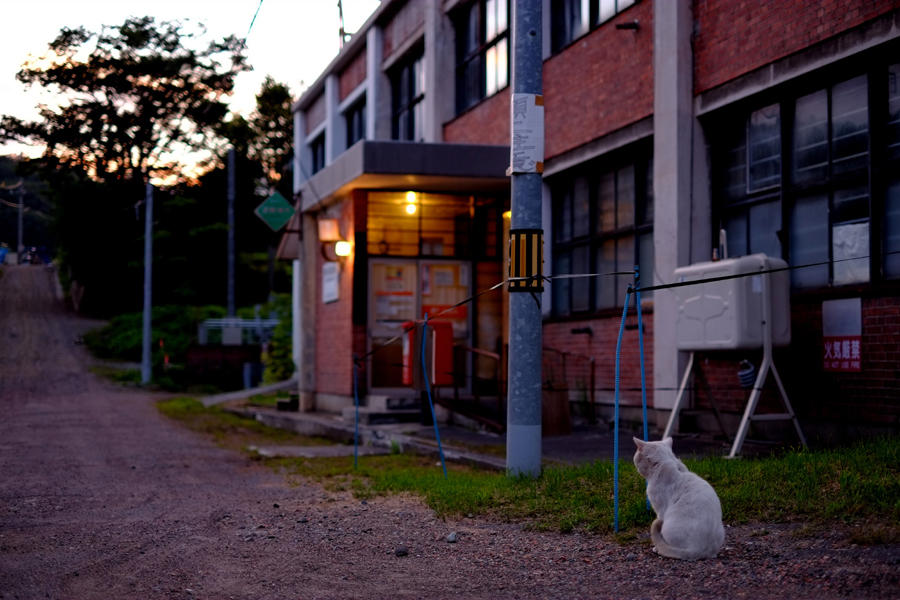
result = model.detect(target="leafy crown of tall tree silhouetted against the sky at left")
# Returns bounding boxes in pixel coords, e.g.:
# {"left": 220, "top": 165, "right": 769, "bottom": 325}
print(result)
{"left": 0, "top": 17, "right": 250, "bottom": 181}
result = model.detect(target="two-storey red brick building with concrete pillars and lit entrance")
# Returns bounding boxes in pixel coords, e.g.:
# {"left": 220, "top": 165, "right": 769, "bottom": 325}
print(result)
{"left": 280, "top": 0, "right": 900, "bottom": 434}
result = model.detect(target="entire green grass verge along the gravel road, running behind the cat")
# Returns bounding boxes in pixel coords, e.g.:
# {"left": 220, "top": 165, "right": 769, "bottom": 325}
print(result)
{"left": 153, "top": 399, "right": 900, "bottom": 543}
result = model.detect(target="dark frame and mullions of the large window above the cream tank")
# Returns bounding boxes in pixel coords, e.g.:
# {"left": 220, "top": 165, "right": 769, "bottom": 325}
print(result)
{"left": 704, "top": 54, "right": 900, "bottom": 294}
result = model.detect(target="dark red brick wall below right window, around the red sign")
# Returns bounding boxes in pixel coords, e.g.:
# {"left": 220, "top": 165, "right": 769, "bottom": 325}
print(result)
{"left": 688, "top": 297, "right": 900, "bottom": 427}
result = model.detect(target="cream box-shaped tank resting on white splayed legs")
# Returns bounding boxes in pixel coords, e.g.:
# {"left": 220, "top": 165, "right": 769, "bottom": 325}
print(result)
{"left": 673, "top": 254, "right": 791, "bottom": 351}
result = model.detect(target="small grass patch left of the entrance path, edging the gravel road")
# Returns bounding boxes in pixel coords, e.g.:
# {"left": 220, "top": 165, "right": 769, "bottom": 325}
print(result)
{"left": 157, "top": 398, "right": 334, "bottom": 449}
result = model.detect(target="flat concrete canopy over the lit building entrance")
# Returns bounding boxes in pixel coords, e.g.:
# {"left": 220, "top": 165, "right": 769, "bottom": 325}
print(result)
{"left": 278, "top": 140, "right": 510, "bottom": 259}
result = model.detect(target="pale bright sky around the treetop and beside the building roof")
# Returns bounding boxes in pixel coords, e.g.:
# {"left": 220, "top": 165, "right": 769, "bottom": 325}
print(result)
{"left": 0, "top": 0, "right": 379, "bottom": 156}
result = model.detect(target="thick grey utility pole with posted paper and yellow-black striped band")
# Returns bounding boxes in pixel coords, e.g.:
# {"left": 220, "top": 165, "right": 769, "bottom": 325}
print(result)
{"left": 506, "top": 0, "right": 544, "bottom": 477}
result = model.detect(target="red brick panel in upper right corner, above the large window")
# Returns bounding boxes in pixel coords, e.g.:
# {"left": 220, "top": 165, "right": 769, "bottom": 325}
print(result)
{"left": 694, "top": 0, "right": 900, "bottom": 94}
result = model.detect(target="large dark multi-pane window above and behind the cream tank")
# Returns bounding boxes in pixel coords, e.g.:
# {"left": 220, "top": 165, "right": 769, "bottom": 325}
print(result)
{"left": 712, "top": 64, "right": 900, "bottom": 289}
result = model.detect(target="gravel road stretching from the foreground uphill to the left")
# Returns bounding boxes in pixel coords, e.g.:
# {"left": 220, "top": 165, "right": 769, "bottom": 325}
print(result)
{"left": 0, "top": 266, "right": 900, "bottom": 600}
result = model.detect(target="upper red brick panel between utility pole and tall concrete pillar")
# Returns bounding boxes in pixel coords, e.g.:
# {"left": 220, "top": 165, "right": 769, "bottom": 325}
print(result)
{"left": 536, "top": 0, "right": 652, "bottom": 158}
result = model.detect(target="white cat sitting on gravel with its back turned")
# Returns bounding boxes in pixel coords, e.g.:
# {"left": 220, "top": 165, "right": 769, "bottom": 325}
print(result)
{"left": 634, "top": 437, "right": 725, "bottom": 560}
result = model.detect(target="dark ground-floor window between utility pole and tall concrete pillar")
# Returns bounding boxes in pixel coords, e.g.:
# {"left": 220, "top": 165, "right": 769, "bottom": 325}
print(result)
{"left": 550, "top": 149, "right": 653, "bottom": 315}
